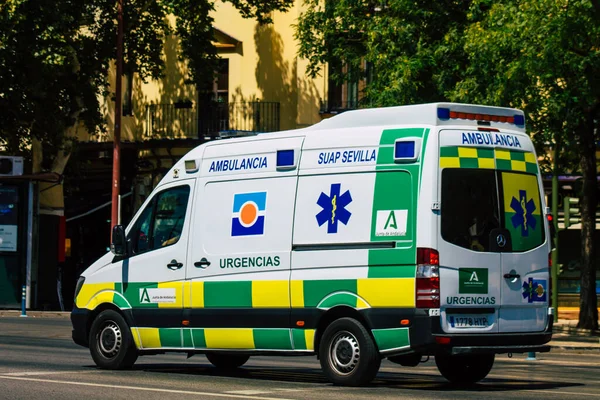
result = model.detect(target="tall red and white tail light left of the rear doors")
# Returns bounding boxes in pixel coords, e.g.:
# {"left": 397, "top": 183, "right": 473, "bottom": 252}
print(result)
{"left": 415, "top": 248, "right": 440, "bottom": 308}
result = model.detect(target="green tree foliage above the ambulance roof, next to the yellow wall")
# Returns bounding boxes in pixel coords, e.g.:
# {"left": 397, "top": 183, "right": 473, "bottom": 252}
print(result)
{"left": 296, "top": 0, "right": 471, "bottom": 106}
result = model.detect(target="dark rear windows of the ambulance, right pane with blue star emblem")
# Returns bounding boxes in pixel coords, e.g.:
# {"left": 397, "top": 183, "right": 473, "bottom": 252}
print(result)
{"left": 441, "top": 168, "right": 545, "bottom": 252}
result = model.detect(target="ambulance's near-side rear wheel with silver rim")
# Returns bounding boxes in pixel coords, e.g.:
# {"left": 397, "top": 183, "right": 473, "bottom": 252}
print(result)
{"left": 319, "top": 318, "right": 381, "bottom": 386}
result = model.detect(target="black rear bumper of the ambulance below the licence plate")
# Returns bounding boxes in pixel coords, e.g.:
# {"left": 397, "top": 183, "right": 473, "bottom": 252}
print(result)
{"left": 410, "top": 310, "right": 554, "bottom": 355}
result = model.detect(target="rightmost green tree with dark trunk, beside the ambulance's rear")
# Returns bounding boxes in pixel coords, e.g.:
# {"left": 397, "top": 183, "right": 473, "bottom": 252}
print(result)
{"left": 447, "top": 0, "right": 600, "bottom": 329}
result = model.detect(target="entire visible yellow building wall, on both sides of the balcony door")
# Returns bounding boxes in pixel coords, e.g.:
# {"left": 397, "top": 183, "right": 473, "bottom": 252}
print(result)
{"left": 79, "top": 0, "right": 326, "bottom": 142}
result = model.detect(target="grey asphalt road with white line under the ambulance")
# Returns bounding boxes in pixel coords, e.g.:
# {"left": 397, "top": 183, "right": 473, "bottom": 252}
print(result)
{"left": 0, "top": 317, "right": 600, "bottom": 400}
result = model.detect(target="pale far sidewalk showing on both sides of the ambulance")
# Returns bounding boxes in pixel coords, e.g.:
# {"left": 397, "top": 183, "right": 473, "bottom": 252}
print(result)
{"left": 0, "top": 309, "right": 600, "bottom": 351}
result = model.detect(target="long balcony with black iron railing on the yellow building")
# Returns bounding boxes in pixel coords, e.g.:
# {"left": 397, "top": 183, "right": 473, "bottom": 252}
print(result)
{"left": 143, "top": 101, "right": 280, "bottom": 140}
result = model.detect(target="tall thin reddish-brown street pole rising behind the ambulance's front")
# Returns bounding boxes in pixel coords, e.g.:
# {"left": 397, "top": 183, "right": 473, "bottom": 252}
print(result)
{"left": 110, "top": 0, "right": 123, "bottom": 242}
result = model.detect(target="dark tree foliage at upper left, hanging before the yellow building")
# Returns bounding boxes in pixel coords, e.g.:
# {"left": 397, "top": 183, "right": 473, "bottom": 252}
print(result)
{"left": 0, "top": 0, "right": 293, "bottom": 212}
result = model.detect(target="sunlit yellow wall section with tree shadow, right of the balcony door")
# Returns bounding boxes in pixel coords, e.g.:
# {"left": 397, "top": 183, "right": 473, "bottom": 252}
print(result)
{"left": 213, "top": 1, "right": 325, "bottom": 130}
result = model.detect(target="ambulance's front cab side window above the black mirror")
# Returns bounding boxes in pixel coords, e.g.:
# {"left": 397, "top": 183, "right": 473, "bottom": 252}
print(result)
{"left": 128, "top": 185, "right": 190, "bottom": 255}
